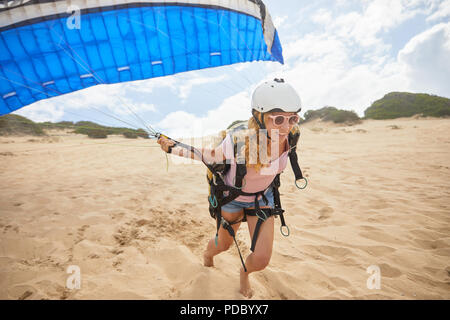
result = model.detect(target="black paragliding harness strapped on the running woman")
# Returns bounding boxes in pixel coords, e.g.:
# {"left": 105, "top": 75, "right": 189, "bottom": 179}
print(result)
{"left": 207, "top": 126, "right": 307, "bottom": 272}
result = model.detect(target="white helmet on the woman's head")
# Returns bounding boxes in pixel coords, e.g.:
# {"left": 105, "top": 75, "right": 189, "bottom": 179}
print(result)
{"left": 252, "top": 79, "right": 302, "bottom": 113}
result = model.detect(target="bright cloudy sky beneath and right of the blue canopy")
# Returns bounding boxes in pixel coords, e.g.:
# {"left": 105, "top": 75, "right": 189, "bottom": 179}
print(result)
{"left": 15, "top": 0, "right": 450, "bottom": 137}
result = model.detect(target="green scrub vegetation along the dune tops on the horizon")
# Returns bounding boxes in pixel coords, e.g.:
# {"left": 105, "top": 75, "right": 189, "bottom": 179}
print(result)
{"left": 0, "top": 92, "right": 450, "bottom": 139}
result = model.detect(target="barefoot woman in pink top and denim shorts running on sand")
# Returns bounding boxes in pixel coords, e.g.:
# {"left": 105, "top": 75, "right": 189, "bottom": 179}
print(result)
{"left": 158, "top": 79, "right": 301, "bottom": 297}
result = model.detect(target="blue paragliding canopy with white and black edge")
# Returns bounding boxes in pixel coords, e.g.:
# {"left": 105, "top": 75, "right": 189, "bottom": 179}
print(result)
{"left": 0, "top": 0, "right": 284, "bottom": 116}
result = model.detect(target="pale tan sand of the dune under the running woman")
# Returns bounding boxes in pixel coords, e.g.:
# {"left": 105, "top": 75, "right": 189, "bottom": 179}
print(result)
{"left": 0, "top": 118, "right": 450, "bottom": 299}
